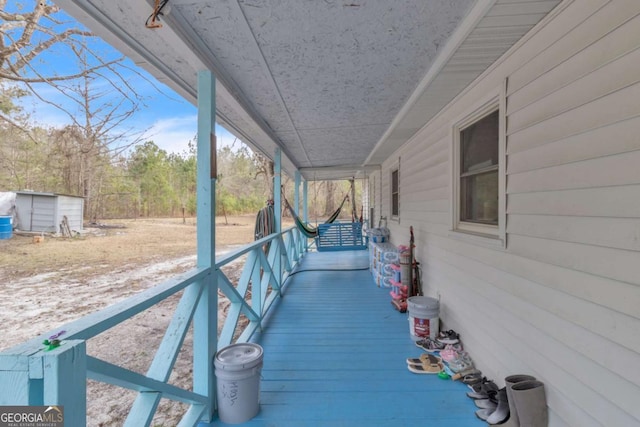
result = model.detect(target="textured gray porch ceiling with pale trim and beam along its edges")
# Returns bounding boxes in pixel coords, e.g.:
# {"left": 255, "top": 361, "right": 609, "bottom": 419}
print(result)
{"left": 57, "top": 0, "right": 560, "bottom": 179}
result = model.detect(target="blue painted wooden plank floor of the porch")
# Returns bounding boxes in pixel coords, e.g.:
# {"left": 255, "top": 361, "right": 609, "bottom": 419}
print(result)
{"left": 206, "top": 251, "right": 486, "bottom": 427}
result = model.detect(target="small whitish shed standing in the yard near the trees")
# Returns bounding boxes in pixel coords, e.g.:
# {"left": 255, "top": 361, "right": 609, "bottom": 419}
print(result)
{"left": 16, "top": 191, "right": 84, "bottom": 233}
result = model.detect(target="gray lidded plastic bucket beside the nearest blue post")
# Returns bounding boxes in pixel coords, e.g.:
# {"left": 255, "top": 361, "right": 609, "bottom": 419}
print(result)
{"left": 214, "top": 343, "right": 263, "bottom": 424}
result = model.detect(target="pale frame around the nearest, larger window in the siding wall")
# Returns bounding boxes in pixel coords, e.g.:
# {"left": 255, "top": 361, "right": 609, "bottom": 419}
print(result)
{"left": 451, "top": 86, "right": 506, "bottom": 248}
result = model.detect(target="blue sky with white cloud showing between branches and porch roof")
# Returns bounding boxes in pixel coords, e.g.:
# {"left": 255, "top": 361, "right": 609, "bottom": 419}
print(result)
{"left": 7, "top": 1, "right": 239, "bottom": 154}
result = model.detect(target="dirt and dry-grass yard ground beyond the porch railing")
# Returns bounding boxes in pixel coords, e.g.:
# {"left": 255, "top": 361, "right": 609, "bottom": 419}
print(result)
{"left": 0, "top": 215, "right": 290, "bottom": 427}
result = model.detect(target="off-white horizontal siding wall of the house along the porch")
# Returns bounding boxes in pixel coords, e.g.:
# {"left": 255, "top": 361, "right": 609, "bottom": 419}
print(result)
{"left": 376, "top": 0, "right": 640, "bottom": 427}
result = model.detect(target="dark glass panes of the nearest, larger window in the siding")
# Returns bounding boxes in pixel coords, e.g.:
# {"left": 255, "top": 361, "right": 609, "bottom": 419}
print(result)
{"left": 459, "top": 111, "right": 500, "bottom": 226}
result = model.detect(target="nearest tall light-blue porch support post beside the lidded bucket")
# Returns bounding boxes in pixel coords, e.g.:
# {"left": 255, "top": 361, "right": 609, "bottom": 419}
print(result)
{"left": 193, "top": 70, "right": 218, "bottom": 422}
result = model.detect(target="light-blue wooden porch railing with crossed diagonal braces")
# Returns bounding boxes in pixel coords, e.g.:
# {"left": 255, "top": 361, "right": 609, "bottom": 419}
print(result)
{"left": 0, "top": 227, "right": 307, "bottom": 427}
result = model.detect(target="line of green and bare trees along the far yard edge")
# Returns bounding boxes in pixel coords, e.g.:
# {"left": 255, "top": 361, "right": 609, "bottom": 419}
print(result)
{"left": 0, "top": 118, "right": 361, "bottom": 221}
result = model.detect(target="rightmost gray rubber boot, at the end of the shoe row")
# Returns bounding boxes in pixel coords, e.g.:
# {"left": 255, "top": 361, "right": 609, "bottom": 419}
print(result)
{"left": 511, "top": 380, "right": 549, "bottom": 427}
